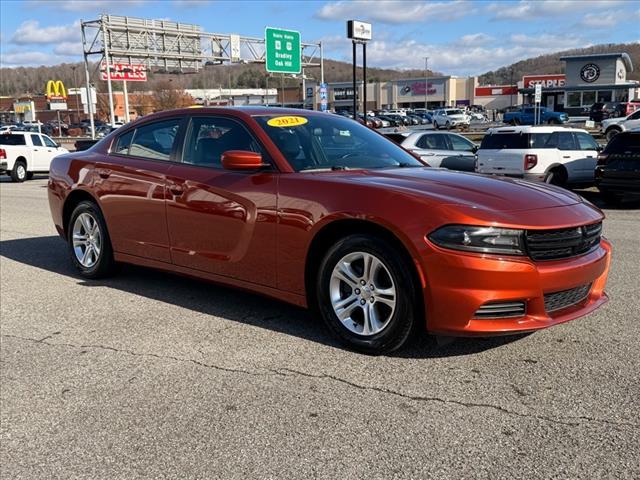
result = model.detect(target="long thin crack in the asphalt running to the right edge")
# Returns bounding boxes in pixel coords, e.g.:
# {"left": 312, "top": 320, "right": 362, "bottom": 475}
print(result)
{"left": 274, "top": 368, "right": 640, "bottom": 428}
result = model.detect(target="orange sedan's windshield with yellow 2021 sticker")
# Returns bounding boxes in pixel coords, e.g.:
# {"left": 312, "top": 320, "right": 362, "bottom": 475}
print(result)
{"left": 255, "top": 114, "right": 425, "bottom": 172}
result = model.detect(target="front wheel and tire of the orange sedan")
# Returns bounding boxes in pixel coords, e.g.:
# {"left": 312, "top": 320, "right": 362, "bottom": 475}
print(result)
{"left": 316, "top": 234, "right": 419, "bottom": 355}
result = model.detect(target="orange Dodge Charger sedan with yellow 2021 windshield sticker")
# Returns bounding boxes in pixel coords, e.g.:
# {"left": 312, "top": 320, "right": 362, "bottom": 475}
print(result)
{"left": 48, "top": 107, "right": 611, "bottom": 353}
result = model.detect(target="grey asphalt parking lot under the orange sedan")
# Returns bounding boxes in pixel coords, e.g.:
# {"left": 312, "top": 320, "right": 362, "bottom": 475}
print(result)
{"left": 0, "top": 176, "right": 640, "bottom": 478}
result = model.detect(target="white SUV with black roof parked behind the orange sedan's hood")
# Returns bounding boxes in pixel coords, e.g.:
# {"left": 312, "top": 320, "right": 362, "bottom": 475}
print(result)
{"left": 476, "top": 126, "right": 601, "bottom": 186}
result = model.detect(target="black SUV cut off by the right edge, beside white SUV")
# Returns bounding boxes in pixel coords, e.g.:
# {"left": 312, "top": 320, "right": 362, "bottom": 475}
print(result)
{"left": 595, "top": 129, "right": 640, "bottom": 204}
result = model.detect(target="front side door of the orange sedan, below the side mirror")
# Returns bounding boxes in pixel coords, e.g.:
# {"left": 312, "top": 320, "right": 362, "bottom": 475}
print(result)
{"left": 167, "top": 116, "right": 278, "bottom": 286}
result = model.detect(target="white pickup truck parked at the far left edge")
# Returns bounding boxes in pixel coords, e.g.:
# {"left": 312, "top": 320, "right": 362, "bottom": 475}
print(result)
{"left": 0, "top": 131, "right": 69, "bottom": 182}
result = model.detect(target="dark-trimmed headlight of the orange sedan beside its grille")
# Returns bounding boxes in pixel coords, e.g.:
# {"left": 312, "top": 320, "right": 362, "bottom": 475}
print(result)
{"left": 428, "top": 225, "right": 525, "bottom": 255}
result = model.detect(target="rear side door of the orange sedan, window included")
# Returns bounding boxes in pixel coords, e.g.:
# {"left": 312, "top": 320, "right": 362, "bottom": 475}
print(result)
{"left": 94, "top": 118, "right": 182, "bottom": 263}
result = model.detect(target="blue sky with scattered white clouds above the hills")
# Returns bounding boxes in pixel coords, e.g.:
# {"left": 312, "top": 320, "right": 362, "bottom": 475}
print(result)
{"left": 0, "top": 0, "right": 640, "bottom": 76}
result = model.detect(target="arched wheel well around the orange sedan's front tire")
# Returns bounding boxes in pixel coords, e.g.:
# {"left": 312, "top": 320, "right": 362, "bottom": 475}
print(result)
{"left": 304, "top": 219, "right": 424, "bottom": 315}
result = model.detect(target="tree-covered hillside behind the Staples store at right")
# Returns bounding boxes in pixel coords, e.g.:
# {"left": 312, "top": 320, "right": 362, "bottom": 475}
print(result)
{"left": 478, "top": 43, "right": 640, "bottom": 85}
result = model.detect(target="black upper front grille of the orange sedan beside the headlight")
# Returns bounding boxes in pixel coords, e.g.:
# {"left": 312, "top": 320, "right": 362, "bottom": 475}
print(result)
{"left": 525, "top": 223, "right": 602, "bottom": 260}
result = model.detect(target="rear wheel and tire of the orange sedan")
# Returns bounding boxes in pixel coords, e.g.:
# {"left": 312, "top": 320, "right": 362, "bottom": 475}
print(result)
{"left": 67, "top": 201, "right": 116, "bottom": 279}
